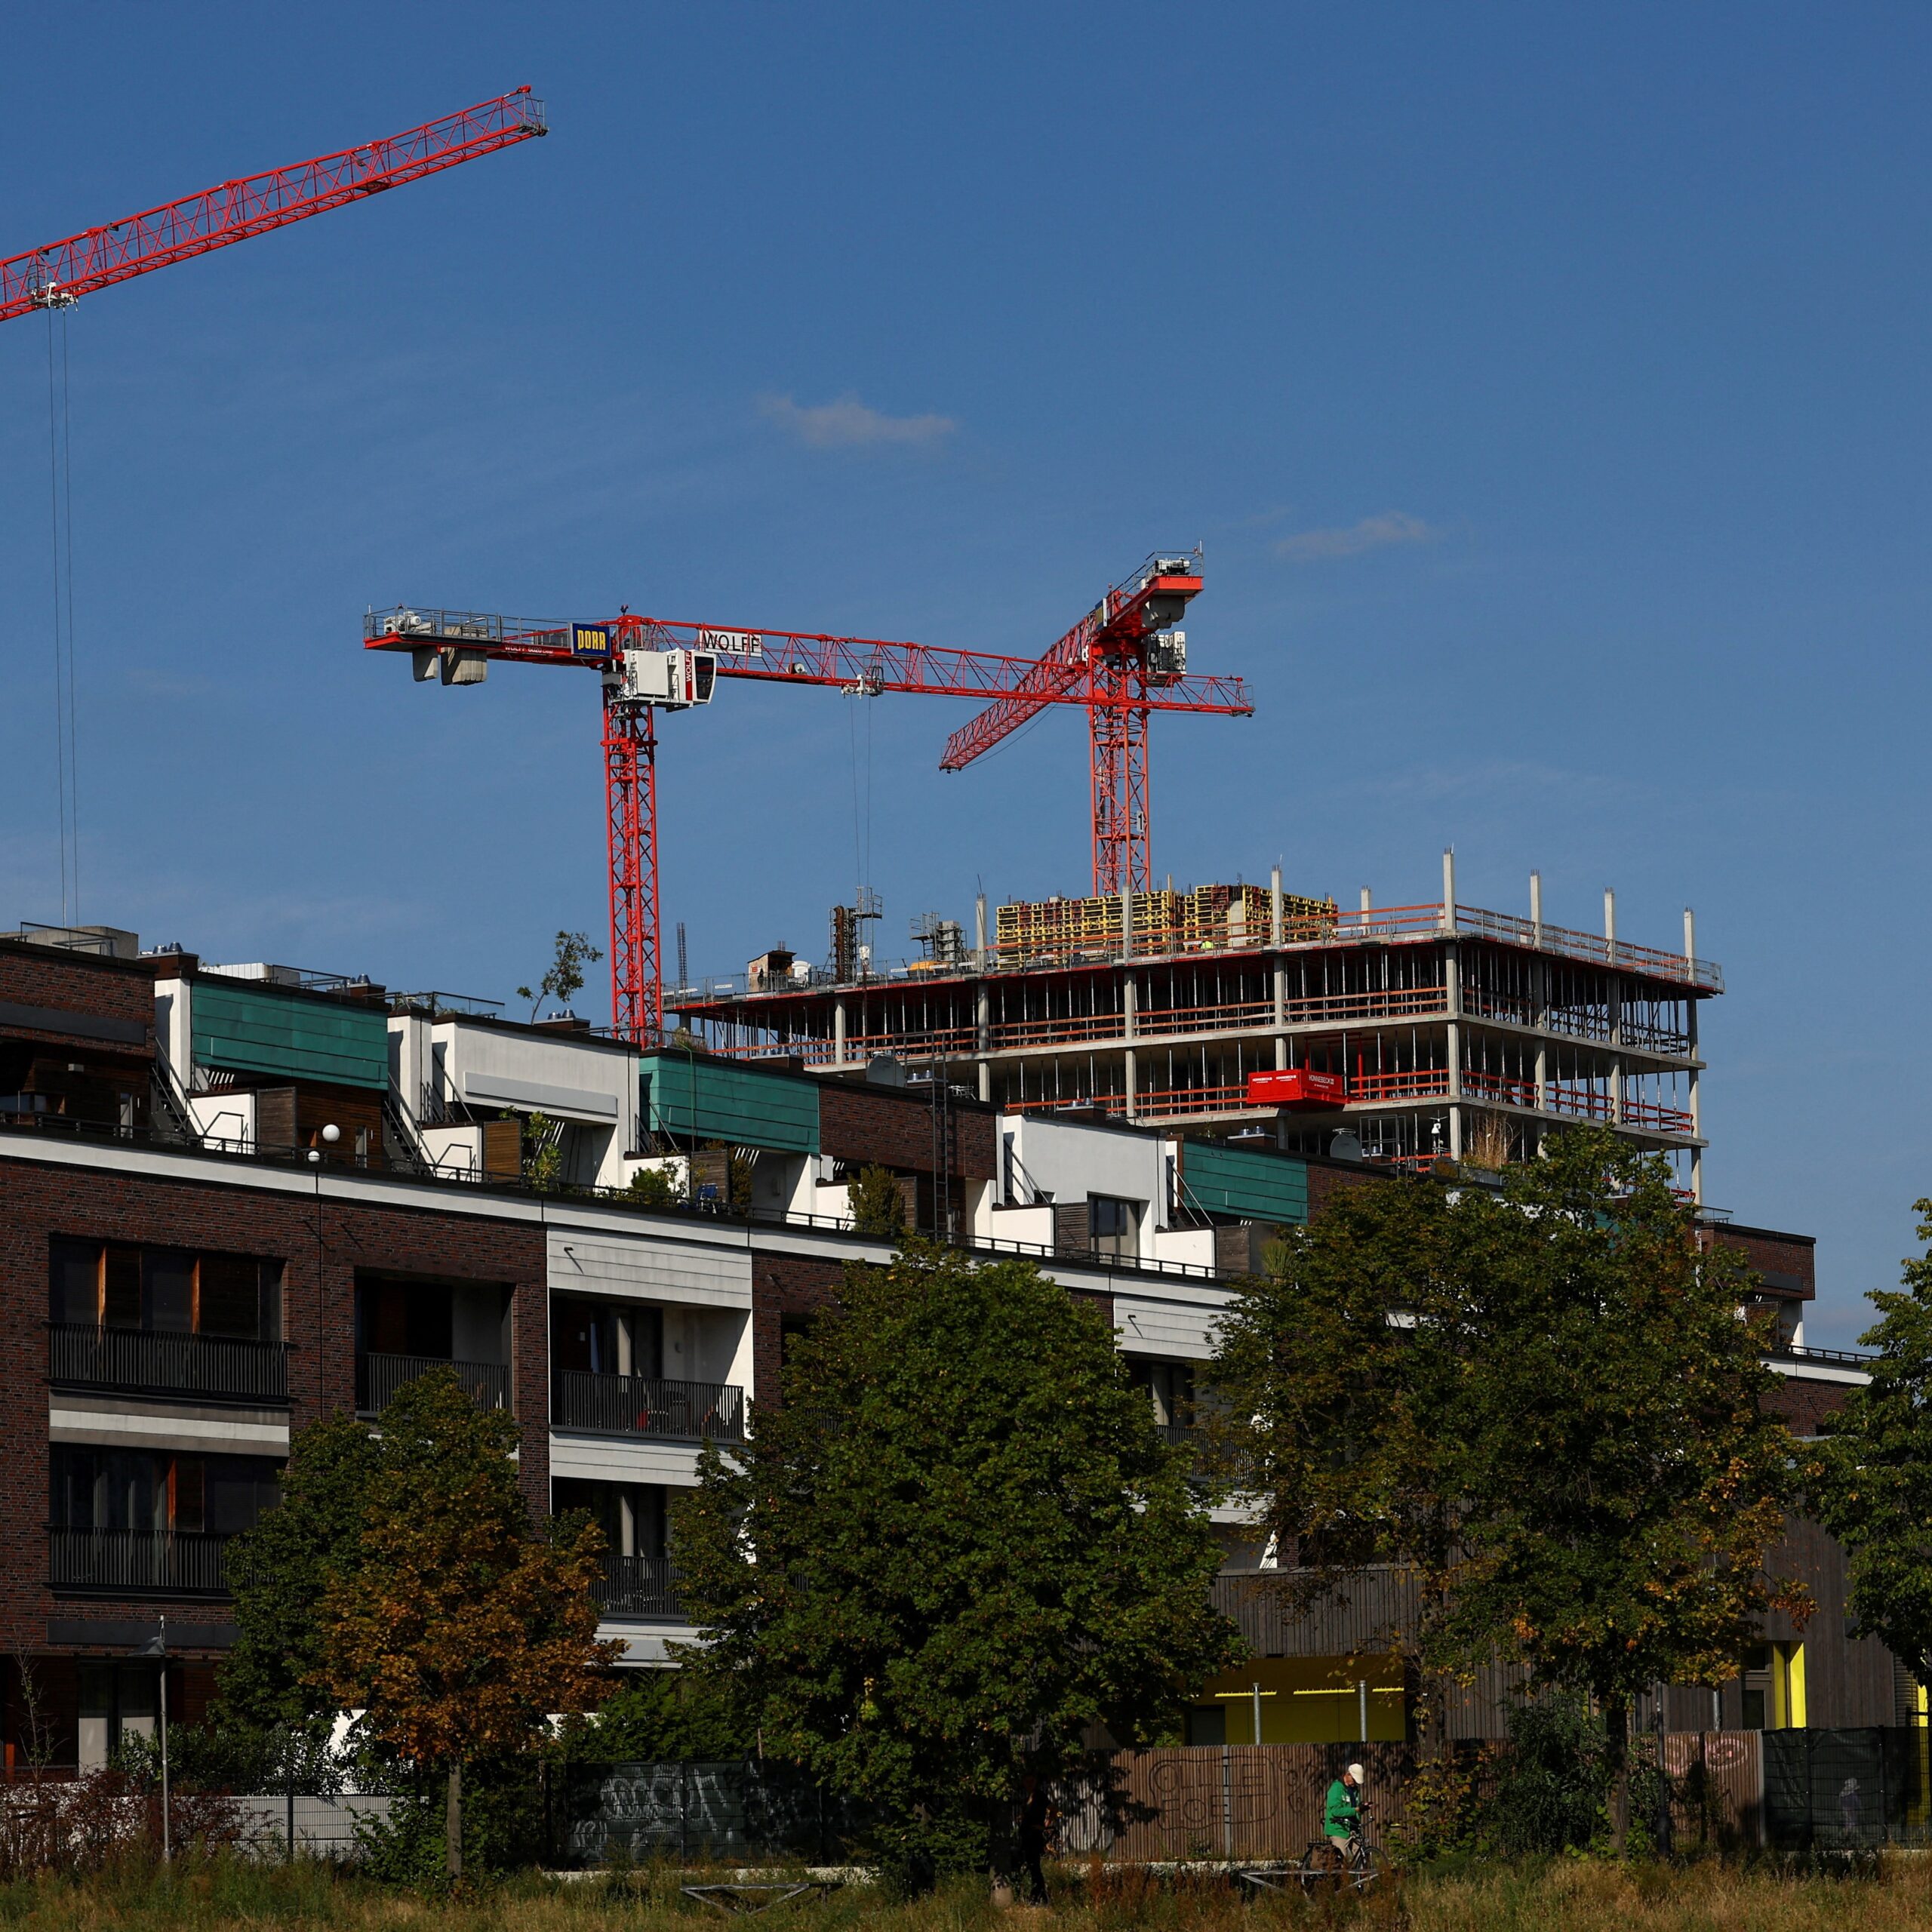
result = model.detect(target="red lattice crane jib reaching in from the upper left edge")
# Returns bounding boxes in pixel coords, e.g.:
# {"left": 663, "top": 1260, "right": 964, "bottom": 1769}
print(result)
{"left": 0, "top": 87, "right": 549, "bottom": 323}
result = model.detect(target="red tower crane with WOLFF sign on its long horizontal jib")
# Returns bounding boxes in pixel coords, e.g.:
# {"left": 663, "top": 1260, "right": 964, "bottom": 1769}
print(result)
{"left": 363, "top": 598, "right": 1254, "bottom": 1043}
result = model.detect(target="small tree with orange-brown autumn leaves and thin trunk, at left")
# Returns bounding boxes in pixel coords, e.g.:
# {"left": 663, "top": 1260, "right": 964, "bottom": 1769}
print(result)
{"left": 315, "top": 1367, "right": 620, "bottom": 1878}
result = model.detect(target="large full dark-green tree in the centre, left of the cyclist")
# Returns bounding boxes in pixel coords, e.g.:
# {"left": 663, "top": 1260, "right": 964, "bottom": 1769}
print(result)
{"left": 674, "top": 1244, "right": 1238, "bottom": 1881}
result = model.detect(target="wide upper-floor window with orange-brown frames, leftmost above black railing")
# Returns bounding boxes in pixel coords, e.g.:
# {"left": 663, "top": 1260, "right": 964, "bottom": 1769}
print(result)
{"left": 48, "top": 1236, "right": 282, "bottom": 1341}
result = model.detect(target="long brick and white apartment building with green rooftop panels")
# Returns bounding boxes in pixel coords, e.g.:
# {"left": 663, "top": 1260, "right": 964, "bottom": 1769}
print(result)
{"left": 0, "top": 929, "right": 1890, "bottom": 1764}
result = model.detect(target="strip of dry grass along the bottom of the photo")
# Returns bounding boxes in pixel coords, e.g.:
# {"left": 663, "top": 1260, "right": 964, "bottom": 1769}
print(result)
{"left": 0, "top": 1859, "right": 1932, "bottom": 1932}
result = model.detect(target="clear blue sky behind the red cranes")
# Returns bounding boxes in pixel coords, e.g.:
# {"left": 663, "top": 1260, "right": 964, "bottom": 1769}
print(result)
{"left": 0, "top": 4, "right": 1932, "bottom": 1341}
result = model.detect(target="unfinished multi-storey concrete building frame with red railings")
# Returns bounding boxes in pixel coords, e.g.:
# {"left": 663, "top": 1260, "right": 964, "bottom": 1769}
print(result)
{"left": 666, "top": 854, "right": 1724, "bottom": 1200}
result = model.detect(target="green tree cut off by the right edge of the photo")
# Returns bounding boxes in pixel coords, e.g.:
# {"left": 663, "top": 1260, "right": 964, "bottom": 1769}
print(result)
{"left": 1812, "top": 1200, "right": 1932, "bottom": 1708}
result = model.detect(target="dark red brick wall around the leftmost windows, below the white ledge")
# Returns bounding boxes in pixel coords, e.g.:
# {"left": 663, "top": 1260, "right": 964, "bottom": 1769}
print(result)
{"left": 0, "top": 1159, "right": 551, "bottom": 1650}
